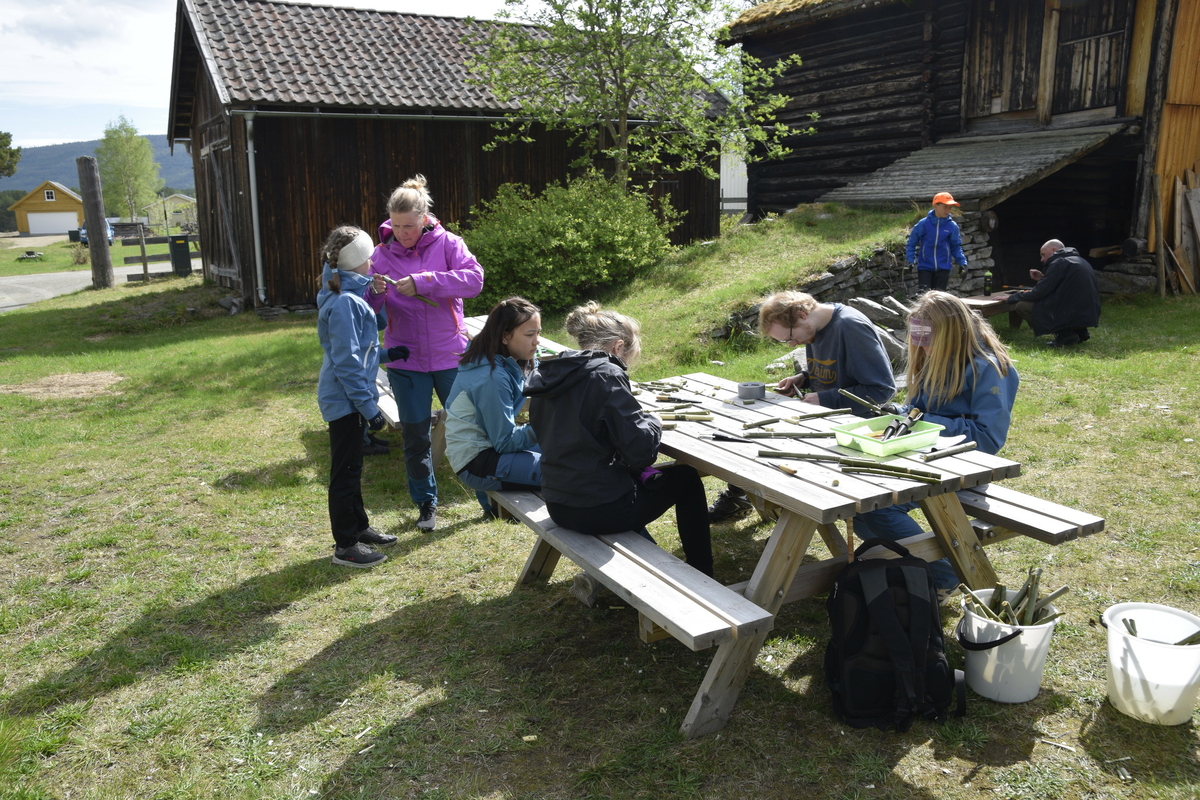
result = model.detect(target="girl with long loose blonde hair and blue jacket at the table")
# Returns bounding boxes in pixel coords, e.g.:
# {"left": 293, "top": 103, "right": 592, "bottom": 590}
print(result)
{"left": 854, "top": 291, "right": 1020, "bottom": 594}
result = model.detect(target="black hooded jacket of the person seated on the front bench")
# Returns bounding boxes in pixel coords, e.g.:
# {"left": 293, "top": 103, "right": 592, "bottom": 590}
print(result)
{"left": 524, "top": 350, "right": 662, "bottom": 509}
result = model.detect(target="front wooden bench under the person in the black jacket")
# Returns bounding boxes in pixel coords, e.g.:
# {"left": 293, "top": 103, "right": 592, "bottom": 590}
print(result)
{"left": 488, "top": 492, "right": 774, "bottom": 650}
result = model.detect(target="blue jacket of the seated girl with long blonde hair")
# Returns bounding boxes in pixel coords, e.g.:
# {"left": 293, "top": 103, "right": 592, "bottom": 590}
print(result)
{"left": 904, "top": 357, "right": 1021, "bottom": 455}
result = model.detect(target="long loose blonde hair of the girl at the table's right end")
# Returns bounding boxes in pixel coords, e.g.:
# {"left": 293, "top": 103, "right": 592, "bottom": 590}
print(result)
{"left": 908, "top": 291, "right": 1013, "bottom": 405}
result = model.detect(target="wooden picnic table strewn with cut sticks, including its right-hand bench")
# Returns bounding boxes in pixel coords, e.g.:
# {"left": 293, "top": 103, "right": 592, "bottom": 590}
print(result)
{"left": 609, "top": 373, "right": 1104, "bottom": 736}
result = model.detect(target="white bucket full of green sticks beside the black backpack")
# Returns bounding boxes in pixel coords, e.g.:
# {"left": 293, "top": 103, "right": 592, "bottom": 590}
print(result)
{"left": 955, "top": 589, "right": 1058, "bottom": 703}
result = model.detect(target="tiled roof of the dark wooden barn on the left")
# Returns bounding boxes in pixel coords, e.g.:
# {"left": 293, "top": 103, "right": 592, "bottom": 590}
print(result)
{"left": 176, "top": 0, "right": 530, "bottom": 113}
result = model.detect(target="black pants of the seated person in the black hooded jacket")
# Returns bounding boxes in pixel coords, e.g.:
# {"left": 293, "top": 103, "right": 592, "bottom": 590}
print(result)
{"left": 546, "top": 464, "right": 713, "bottom": 576}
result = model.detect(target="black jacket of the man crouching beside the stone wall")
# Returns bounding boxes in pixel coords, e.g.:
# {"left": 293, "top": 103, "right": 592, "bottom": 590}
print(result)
{"left": 1008, "top": 247, "right": 1100, "bottom": 336}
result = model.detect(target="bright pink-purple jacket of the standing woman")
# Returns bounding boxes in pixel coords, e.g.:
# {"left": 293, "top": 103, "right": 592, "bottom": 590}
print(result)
{"left": 367, "top": 216, "right": 484, "bottom": 372}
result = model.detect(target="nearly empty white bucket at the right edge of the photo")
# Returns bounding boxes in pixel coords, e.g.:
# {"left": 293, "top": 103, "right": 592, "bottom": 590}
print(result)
{"left": 1102, "top": 603, "right": 1200, "bottom": 724}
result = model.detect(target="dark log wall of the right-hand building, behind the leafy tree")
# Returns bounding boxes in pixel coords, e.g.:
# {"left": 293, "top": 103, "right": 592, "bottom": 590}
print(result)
{"left": 743, "top": 0, "right": 968, "bottom": 212}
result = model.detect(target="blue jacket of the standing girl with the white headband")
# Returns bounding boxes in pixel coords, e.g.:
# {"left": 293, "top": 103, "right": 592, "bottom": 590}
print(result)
{"left": 317, "top": 264, "right": 379, "bottom": 422}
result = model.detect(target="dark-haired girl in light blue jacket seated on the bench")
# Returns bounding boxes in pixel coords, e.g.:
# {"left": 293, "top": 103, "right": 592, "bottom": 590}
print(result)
{"left": 445, "top": 297, "right": 541, "bottom": 516}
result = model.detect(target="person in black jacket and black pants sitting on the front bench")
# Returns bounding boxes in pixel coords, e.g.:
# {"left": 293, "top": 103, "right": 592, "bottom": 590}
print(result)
{"left": 524, "top": 302, "right": 713, "bottom": 576}
